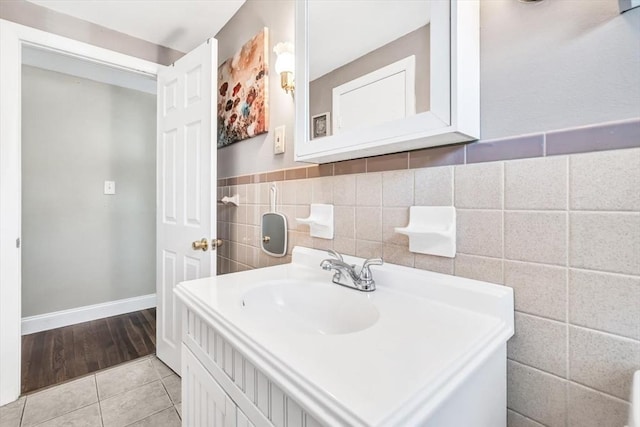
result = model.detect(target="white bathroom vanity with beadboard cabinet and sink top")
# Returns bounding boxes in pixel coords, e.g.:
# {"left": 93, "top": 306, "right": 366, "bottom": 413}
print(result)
{"left": 174, "top": 247, "right": 513, "bottom": 427}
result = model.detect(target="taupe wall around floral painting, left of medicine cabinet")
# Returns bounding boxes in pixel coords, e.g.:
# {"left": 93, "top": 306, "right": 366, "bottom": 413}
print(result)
{"left": 216, "top": 0, "right": 295, "bottom": 177}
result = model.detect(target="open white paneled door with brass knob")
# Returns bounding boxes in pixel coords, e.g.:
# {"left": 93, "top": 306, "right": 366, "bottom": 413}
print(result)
{"left": 156, "top": 39, "right": 217, "bottom": 373}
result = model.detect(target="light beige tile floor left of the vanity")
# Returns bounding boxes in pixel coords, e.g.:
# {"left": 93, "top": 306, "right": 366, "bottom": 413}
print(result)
{"left": 0, "top": 356, "right": 181, "bottom": 427}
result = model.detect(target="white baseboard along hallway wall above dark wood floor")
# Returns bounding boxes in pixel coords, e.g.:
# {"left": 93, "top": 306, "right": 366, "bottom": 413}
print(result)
{"left": 22, "top": 294, "right": 156, "bottom": 335}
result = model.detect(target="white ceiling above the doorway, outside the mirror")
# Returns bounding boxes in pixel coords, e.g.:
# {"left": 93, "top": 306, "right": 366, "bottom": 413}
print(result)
{"left": 28, "top": 0, "right": 245, "bottom": 52}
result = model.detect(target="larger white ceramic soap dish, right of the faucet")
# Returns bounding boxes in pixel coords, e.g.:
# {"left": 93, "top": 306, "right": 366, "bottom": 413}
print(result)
{"left": 395, "top": 206, "right": 456, "bottom": 258}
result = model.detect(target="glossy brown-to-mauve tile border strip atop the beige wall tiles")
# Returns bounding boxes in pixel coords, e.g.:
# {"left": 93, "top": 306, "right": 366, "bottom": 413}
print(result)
{"left": 217, "top": 119, "right": 640, "bottom": 187}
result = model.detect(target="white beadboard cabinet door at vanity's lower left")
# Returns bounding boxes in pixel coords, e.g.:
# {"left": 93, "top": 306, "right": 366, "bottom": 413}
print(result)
{"left": 182, "top": 345, "right": 238, "bottom": 427}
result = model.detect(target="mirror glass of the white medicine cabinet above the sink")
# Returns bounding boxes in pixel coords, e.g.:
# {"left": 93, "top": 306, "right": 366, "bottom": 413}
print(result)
{"left": 308, "top": 0, "right": 431, "bottom": 139}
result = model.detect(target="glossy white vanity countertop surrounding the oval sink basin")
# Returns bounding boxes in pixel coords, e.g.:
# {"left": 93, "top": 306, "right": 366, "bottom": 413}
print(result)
{"left": 176, "top": 248, "right": 513, "bottom": 426}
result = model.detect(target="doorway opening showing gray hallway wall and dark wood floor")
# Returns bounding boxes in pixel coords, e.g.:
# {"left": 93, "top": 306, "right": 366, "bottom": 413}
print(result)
{"left": 21, "top": 46, "right": 156, "bottom": 393}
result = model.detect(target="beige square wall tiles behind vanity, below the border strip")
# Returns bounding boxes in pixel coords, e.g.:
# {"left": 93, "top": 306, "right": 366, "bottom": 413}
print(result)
{"left": 218, "top": 148, "right": 640, "bottom": 427}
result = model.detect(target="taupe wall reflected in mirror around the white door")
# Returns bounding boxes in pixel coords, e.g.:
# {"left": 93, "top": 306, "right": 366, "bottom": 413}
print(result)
{"left": 309, "top": 25, "right": 431, "bottom": 126}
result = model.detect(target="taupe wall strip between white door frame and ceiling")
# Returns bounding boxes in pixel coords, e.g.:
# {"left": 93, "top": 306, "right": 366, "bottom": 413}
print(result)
{"left": 0, "top": 0, "right": 184, "bottom": 65}
